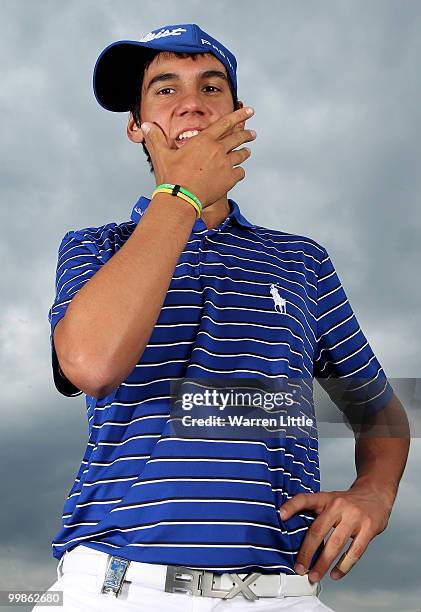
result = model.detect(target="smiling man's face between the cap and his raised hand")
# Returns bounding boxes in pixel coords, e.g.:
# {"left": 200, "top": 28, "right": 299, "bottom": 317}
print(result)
{"left": 127, "top": 54, "right": 244, "bottom": 149}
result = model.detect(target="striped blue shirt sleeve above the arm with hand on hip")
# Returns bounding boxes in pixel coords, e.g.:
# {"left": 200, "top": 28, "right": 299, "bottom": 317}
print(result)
{"left": 313, "top": 249, "right": 393, "bottom": 413}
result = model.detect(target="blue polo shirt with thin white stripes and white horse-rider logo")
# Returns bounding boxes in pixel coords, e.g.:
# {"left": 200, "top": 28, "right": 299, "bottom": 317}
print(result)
{"left": 48, "top": 197, "right": 393, "bottom": 574}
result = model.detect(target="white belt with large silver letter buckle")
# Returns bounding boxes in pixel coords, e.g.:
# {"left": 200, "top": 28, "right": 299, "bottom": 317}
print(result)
{"left": 57, "top": 545, "right": 321, "bottom": 600}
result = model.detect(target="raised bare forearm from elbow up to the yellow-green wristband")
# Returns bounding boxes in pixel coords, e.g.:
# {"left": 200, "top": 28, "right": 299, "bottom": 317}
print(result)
{"left": 63, "top": 194, "right": 195, "bottom": 396}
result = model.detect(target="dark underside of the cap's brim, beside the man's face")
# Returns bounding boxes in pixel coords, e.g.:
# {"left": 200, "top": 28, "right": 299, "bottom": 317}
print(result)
{"left": 93, "top": 41, "right": 148, "bottom": 112}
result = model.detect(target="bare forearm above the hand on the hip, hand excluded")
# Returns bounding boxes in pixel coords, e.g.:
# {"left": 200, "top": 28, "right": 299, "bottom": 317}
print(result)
{"left": 351, "top": 395, "right": 410, "bottom": 509}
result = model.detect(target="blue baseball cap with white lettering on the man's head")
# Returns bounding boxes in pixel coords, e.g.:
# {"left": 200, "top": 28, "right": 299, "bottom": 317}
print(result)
{"left": 93, "top": 23, "right": 237, "bottom": 112}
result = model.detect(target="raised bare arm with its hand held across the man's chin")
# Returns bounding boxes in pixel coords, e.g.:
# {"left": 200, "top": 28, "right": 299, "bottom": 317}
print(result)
{"left": 54, "top": 108, "right": 255, "bottom": 397}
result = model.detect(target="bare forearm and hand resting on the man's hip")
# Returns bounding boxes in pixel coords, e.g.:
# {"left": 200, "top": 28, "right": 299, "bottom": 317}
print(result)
{"left": 281, "top": 395, "right": 409, "bottom": 582}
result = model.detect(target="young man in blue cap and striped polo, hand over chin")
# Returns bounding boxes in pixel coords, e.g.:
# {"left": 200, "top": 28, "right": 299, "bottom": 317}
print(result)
{"left": 38, "top": 24, "right": 408, "bottom": 611}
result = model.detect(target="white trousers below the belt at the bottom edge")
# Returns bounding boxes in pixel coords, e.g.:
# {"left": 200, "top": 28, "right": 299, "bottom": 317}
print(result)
{"left": 32, "top": 547, "right": 333, "bottom": 612}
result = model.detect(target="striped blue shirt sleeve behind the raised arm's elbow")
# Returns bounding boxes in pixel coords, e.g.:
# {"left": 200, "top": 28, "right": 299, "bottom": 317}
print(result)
{"left": 48, "top": 231, "right": 103, "bottom": 397}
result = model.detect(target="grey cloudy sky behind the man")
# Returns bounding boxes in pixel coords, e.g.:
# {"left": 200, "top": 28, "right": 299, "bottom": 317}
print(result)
{"left": 0, "top": 0, "right": 421, "bottom": 612}
